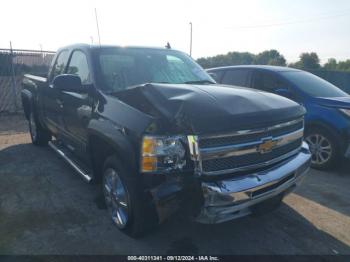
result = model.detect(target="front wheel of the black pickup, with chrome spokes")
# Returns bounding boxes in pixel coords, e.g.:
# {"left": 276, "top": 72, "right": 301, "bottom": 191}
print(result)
{"left": 102, "top": 155, "right": 158, "bottom": 238}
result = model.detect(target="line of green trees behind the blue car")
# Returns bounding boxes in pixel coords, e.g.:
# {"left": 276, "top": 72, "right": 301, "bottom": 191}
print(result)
{"left": 197, "top": 49, "right": 350, "bottom": 72}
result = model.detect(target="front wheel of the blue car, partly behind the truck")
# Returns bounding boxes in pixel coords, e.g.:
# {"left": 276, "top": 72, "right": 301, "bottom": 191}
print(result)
{"left": 305, "top": 127, "right": 340, "bottom": 170}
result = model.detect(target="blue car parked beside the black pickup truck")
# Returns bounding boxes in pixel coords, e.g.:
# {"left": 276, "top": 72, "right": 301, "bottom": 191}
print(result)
{"left": 207, "top": 66, "right": 350, "bottom": 169}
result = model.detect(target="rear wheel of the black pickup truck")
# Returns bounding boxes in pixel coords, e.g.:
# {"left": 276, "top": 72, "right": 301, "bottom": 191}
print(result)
{"left": 28, "top": 110, "right": 51, "bottom": 146}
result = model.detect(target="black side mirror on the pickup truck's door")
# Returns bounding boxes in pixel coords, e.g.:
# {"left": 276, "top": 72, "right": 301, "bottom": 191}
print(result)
{"left": 52, "top": 74, "right": 87, "bottom": 93}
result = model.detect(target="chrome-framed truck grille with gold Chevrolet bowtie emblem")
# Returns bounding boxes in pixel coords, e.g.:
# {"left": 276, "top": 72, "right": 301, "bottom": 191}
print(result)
{"left": 189, "top": 118, "right": 304, "bottom": 175}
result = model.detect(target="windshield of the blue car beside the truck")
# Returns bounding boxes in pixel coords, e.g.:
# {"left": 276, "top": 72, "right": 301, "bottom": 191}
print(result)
{"left": 282, "top": 71, "right": 348, "bottom": 97}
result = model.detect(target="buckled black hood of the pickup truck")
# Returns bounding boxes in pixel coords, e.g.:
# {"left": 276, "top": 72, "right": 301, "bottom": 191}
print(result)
{"left": 114, "top": 83, "right": 305, "bottom": 134}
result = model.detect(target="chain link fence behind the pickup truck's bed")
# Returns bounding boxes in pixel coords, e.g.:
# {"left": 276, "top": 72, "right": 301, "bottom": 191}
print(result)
{"left": 0, "top": 49, "right": 55, "bottom": 114}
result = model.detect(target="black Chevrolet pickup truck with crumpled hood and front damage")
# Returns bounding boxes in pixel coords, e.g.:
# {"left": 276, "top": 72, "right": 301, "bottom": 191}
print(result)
{"left": 21, "top": 45, "right": 310, "bottom": 236}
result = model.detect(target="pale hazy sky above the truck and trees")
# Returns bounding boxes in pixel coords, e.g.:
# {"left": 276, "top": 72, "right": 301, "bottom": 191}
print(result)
{"left": 0, "top": 0, "right": 350, "bottom": 62}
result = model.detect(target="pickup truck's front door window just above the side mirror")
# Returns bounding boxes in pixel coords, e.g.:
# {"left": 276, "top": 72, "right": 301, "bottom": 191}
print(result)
{"left": 67, "top": 51, "right": 91, "bottom": 84}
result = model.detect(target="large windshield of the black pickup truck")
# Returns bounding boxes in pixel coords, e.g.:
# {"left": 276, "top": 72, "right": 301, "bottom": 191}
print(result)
{"left": 95, "top": 48, "right": 214, "bottom": 92}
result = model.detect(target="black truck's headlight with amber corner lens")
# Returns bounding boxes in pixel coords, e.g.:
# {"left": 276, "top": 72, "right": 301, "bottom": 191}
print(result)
{"left": 141, "top": 136, "right": 186, "bottom": 173}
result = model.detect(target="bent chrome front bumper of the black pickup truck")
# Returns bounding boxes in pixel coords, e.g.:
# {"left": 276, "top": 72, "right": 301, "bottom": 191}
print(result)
{"left": 196, "top": 142, "right": 311, "bottom": 224}
